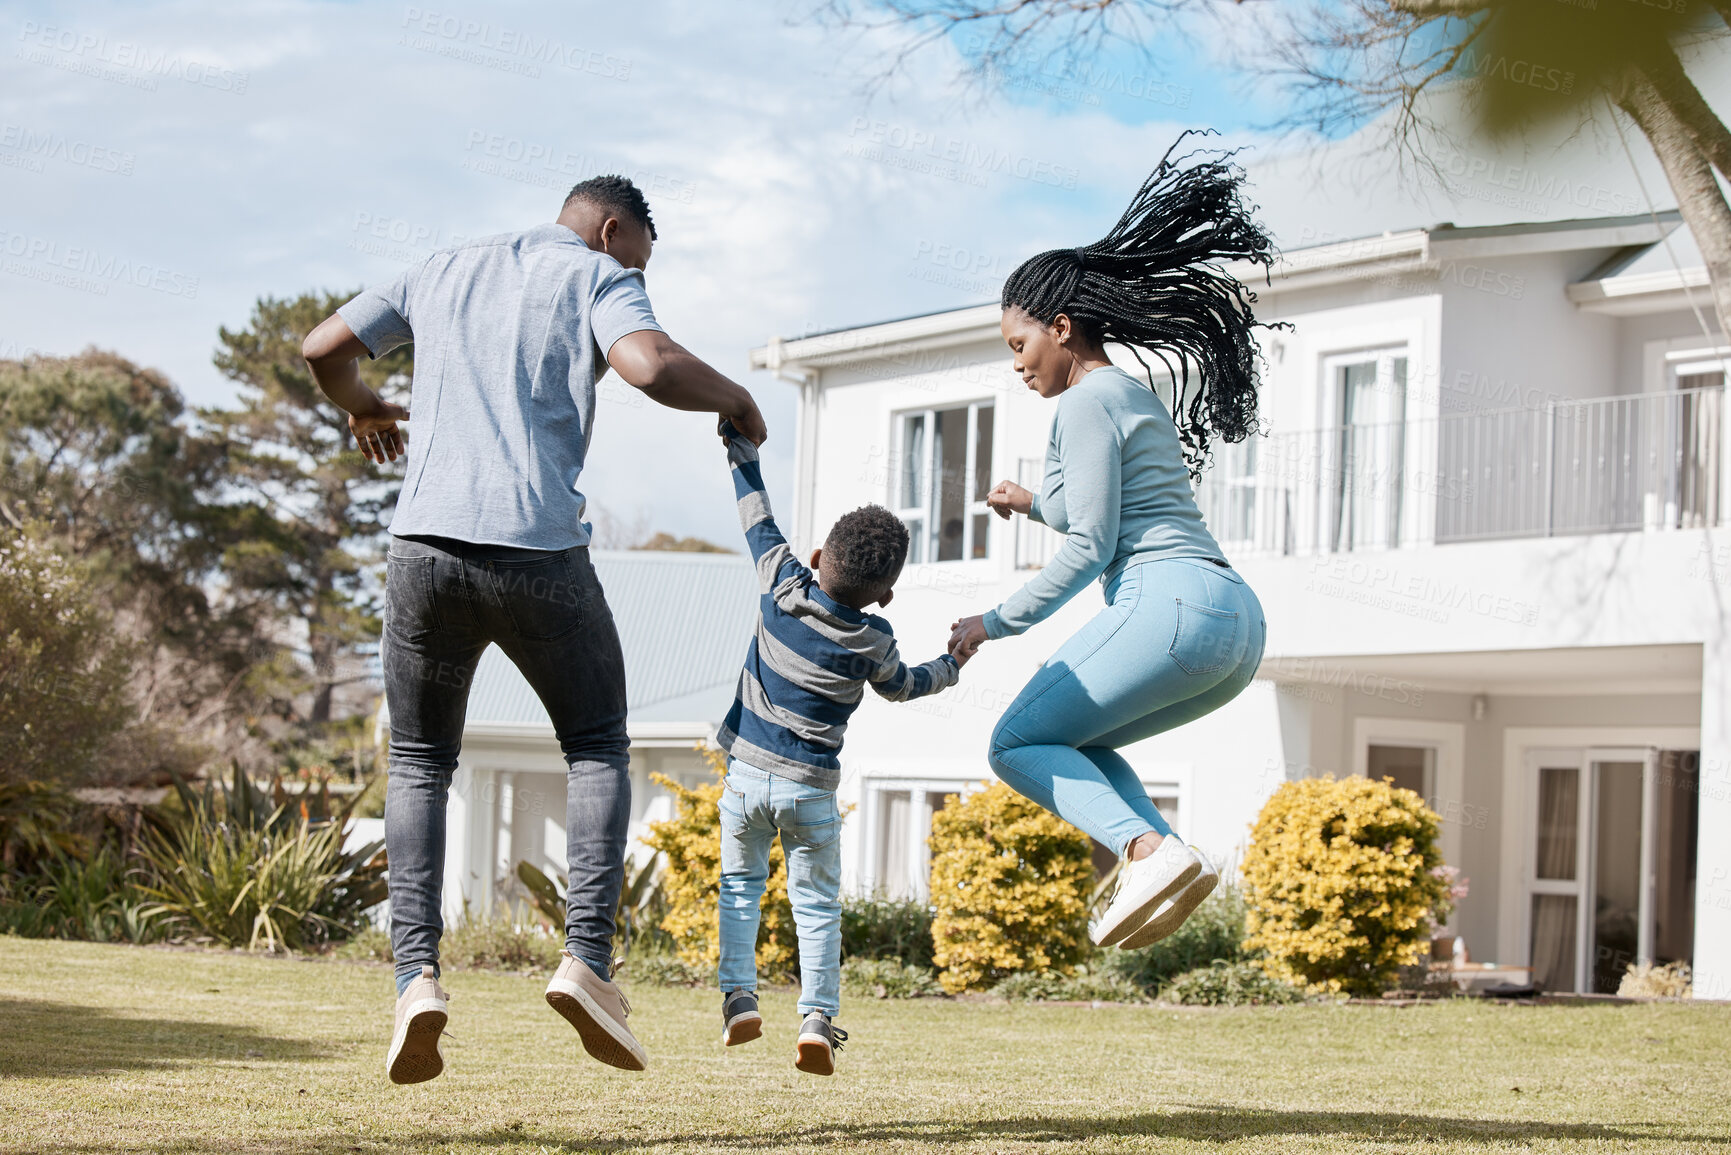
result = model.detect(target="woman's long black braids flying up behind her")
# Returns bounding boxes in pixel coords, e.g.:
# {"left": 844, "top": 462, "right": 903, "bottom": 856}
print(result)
{"left": 1002, "top": 132, "right": 1283, "bottom": 478}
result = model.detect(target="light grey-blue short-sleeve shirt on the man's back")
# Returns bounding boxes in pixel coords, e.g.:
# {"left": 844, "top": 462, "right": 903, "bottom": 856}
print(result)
{"left": 338, "top": 225, "right": 661, "bottom": 549}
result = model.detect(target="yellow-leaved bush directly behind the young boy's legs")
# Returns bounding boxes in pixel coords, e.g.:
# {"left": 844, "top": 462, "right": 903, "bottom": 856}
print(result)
{"left": 644, "top": 746, "right": 800, "bottom": 978}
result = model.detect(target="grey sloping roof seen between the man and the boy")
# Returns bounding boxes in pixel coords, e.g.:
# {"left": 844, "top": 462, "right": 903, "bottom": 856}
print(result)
{"left": 467, "top": 551, "right": 758, "bottom": 729}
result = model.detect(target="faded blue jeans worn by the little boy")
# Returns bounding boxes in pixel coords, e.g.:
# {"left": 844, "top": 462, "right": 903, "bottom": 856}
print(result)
{"left": 718, "top": 758, "right": 841, "bottom": 1016}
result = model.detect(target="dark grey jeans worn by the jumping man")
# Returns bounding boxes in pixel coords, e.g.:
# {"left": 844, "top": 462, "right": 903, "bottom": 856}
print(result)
{"left": 383, "top": 537, "right": 632, "bottom": 980}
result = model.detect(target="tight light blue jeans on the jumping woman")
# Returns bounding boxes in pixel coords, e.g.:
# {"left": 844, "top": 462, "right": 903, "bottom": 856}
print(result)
{"left": 990, "top": 558, "right": 1265, "bottom": 854}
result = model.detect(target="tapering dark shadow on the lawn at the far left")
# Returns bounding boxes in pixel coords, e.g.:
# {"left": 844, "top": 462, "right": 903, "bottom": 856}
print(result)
{"left": 0, "top": 997, "right": 325, "bottom": 1079}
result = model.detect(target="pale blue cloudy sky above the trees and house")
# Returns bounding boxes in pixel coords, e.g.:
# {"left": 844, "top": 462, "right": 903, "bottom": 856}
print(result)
{"left": 0, "top": 0, "right": 1703, "bottom": 542}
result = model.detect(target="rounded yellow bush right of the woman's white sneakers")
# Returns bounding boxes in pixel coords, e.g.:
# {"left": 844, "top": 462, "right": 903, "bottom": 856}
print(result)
{"left": 1243, "top": 778, "right": 1452, "bottom": 994}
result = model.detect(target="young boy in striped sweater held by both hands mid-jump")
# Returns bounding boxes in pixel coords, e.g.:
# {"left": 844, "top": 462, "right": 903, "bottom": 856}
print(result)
{"left": 718, "top": 421, "right": 961, "bottom": 1075}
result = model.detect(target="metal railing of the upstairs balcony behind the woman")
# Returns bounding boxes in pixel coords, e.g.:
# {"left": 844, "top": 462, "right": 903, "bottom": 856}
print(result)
{"left": 1196, "top": 386, "right": 1724, "bottom": 554}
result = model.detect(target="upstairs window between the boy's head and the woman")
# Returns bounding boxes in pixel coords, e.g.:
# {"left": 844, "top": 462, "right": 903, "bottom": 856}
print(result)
{"left": 890, "top": 402, "right": 992, "bottom": 565}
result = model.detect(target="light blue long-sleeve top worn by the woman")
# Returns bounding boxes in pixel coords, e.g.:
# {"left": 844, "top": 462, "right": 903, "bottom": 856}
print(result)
{"left": 985, "top": 365, "right": 1224, "bottom": 637}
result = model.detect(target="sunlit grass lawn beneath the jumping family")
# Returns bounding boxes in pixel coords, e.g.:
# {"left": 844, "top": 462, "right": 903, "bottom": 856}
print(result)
{"left": 0, "top": 937, "right": 1731, "bottom": 1155}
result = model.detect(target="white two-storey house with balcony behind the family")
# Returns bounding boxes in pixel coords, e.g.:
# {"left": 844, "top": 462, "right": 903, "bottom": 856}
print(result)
{"left": 439, "top": 213, "right": 1731, "bottom": 997}
